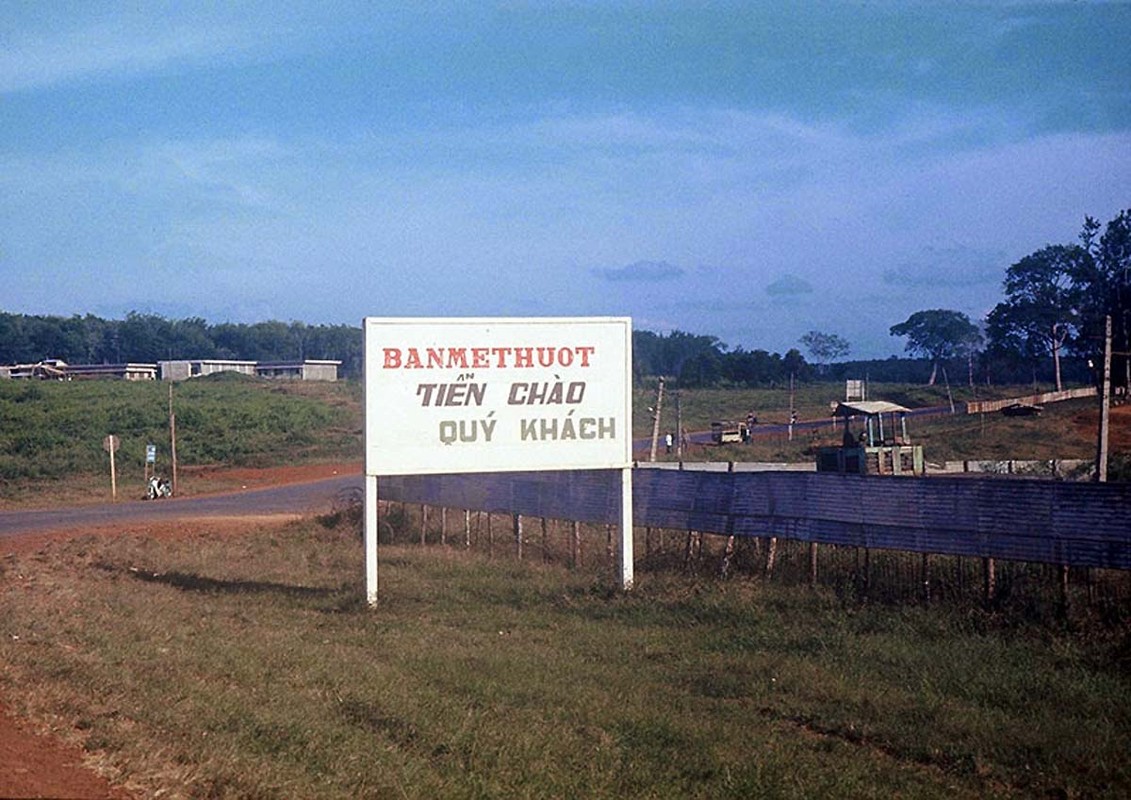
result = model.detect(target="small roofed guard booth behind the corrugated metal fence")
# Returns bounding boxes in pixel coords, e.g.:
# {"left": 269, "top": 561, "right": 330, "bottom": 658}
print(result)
{"left": 817, "top": 401, "right": 925, "bottom": 476}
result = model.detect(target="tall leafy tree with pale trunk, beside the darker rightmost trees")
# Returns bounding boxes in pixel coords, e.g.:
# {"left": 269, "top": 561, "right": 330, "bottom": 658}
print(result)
{"left": 986, "top": 244, "right": 1089, "bottom": 389}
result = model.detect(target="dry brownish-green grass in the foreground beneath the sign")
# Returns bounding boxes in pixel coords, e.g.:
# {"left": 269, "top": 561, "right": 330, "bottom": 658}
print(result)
{"left": 0, "top": 521, "right": 1131, "bottom": 798}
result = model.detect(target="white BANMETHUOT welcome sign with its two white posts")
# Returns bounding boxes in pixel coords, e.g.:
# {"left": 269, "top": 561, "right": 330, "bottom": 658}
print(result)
{"left": 363, "top": 317, "right": 632, "bottom": 605}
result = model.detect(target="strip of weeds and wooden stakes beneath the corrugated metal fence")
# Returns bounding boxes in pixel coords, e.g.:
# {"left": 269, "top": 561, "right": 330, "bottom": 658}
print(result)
{"left": 343, "top": 500, "right": 1131, "bottom": 628}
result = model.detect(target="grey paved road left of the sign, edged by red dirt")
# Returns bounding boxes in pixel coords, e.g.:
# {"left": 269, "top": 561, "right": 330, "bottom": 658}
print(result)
{"left": 0, "top": 475, "right": 363, "bottom": 540}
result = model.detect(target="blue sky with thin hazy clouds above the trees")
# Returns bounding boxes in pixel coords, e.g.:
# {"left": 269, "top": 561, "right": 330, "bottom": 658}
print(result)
{"left": 0, "top": 0, "right": 1131, "bottom": 358}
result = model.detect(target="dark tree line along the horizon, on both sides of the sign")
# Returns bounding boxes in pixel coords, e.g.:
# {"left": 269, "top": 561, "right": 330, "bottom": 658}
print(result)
{"left": 0, "top": 209, "right": 1131, "bottom": 388}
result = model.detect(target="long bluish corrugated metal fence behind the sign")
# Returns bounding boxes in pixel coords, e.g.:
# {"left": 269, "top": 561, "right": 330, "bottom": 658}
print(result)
{"left": 378, "top": 467, "right": 1131, "bottom": 570}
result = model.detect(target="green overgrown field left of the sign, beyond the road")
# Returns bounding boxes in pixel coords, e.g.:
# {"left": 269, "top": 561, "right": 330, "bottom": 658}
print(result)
{"left": 0, "top": 373, "right": 362, "bottom": 498}
